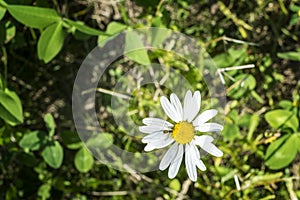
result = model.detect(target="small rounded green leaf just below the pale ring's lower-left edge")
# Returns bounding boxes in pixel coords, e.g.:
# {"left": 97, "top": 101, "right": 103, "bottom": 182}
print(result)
{"left": 74, "top": 147, "right": 94, "bottom": 173}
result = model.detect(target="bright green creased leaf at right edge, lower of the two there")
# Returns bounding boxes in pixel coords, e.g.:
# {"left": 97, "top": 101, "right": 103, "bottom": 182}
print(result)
{"left": 265, "top": 134, "right": 299, "bottom": 170}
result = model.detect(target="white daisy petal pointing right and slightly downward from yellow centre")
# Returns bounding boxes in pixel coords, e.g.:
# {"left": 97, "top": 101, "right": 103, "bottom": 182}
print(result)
{"left": 195, "top": 135, "right": 223, "bottom": 157}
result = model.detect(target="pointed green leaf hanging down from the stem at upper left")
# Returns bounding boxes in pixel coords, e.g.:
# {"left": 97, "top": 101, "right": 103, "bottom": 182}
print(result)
{"left": 38, "top": 22, "right": 66, "bottom": 63}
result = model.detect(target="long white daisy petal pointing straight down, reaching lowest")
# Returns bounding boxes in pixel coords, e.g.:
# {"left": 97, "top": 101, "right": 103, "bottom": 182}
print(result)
{"left": 185, "top": 144, "right": 197, "bottom": 181}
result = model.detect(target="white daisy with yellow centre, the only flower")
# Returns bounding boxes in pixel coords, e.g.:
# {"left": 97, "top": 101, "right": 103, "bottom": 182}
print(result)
{"left": 139, "top": 91, "right": 223, "bottom": 181}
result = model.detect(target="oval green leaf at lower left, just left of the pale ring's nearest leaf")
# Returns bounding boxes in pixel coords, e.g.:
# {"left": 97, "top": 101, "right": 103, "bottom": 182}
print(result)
{"left": 41, "top": 141, "right": 63, "bottom": 169}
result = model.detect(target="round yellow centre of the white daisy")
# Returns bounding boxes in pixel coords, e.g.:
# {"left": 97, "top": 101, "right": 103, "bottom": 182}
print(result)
{"left": 172, "top": 121, "right": 195, "bottom": 144}
